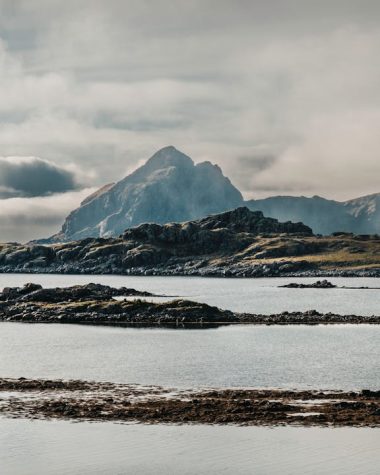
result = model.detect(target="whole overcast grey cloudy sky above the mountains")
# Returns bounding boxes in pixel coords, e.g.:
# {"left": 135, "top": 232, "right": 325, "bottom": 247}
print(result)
{"left": 0, "top": 0, "right": 380, "bottom": 241}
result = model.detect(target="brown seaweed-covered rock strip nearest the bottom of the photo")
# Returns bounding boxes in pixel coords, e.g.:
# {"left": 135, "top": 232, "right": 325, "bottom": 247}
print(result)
{"left": 0, "top": 378, "right": 380, "bottom": 427}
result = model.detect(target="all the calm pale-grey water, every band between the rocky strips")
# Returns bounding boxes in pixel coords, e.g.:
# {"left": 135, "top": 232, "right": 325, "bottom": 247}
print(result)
{"left": 0, "top": 274, "right": 380, "bottom": 475}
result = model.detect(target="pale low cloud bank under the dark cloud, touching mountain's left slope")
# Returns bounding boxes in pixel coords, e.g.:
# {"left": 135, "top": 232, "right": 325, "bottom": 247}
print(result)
{"left": 0, "top": 188, "right": 95, "bottom": 242}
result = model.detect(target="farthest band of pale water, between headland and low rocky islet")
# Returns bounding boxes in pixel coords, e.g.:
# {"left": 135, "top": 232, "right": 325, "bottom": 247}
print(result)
{"left": 0, "top": 274, "right": 380, "bottom": 315}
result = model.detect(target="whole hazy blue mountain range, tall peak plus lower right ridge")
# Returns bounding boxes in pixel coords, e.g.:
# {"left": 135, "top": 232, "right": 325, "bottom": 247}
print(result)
{"left": 39, "top": 146, "right": 380, "bottom": 242}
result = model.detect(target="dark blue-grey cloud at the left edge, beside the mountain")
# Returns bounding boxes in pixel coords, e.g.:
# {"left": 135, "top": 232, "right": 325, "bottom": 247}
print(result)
{"left": 0, "top": 157, "right": 78, "bottom": 198}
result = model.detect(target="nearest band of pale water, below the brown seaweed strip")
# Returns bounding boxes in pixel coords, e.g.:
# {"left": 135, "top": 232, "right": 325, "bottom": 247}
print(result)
{"left": 0, "top": 419, "right": 380, "bottom": 475}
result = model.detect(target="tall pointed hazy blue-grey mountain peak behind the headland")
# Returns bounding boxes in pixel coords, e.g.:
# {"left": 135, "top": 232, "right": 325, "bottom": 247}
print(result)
{"left": 47, "top": 146, "right": 243, "bottom": 242}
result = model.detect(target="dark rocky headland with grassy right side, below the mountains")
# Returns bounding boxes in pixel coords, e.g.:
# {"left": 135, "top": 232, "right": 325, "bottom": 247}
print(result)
{"left": 0, "top": 207, "right": 380, "bottom": 277}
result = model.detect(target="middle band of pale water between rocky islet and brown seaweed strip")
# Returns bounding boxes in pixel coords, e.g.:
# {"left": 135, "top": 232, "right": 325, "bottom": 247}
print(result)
{"left": 0, "top": 323, "right": 380, "bottom": 389}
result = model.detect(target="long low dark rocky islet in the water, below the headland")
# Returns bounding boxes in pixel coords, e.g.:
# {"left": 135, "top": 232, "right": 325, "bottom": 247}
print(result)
{"left": 0, "top": 284, "right": 380, "bottom": 328}
